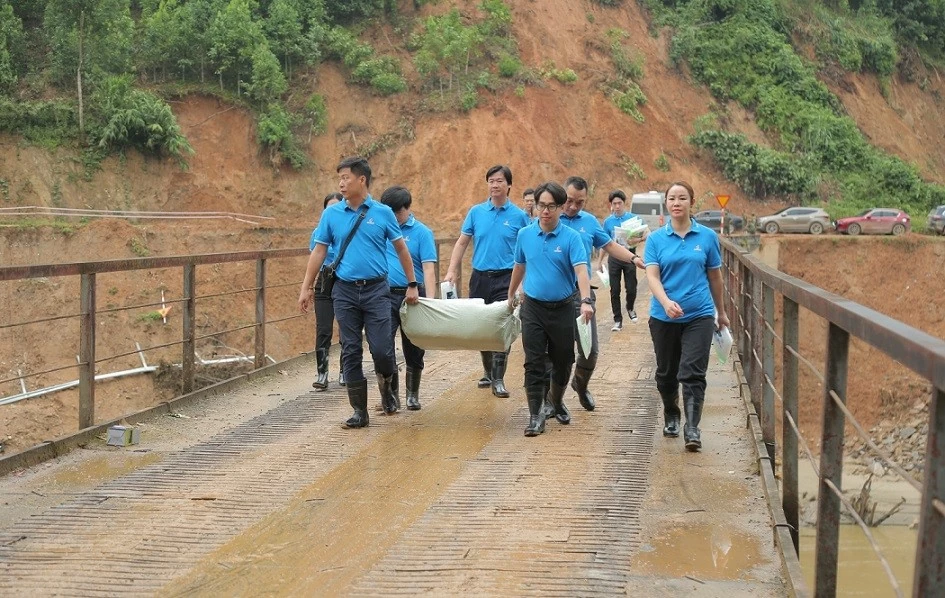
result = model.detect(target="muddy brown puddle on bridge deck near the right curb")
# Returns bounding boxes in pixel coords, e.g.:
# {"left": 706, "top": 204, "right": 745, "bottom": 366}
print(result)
{"left": 634, "top": 524, "right": 765, "bottom": 580}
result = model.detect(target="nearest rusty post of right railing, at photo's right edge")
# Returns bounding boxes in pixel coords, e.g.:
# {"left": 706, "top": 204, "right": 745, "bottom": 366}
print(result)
{"left": 912, "top": 388, "right": 945, "bottom": 598}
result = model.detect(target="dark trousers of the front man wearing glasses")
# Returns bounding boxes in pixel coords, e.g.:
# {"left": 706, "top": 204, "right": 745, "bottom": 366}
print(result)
{"left": 519, "top": 297, "right": 575, "bottom": 392}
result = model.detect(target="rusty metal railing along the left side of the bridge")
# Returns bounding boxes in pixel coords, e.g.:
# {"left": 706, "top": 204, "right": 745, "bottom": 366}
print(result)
{"left": 0, "top": 238, "right": 468, "bottom": 440}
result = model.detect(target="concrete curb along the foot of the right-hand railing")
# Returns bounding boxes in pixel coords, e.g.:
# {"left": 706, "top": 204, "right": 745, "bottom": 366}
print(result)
{"left": 732, "top": 358, "right": 811, "bottom": 598}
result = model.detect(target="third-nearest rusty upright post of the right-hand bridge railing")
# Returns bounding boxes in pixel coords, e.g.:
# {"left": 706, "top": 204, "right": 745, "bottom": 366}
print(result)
{"left": 781, "top": 295, "right": 800, "bottom": 552}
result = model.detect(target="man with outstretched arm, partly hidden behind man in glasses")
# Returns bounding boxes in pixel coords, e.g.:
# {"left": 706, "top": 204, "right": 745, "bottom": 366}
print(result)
{"left": 561, "top": 176, "right": 643, "bottom": 411}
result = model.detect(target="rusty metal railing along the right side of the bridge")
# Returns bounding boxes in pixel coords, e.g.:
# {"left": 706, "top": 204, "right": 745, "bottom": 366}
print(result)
{"left": 722, "top": 239, "right": 945, "bottom": 597}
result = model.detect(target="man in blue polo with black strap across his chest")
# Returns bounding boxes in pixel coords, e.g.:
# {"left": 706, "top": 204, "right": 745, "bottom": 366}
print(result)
{"left": 299, "top": 156, "right": 419, "bottom": 428}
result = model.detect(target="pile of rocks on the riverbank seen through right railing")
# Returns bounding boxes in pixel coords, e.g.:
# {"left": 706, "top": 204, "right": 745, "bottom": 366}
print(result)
{"left": 844, "top": 399, "right": 929, "bottom": 482}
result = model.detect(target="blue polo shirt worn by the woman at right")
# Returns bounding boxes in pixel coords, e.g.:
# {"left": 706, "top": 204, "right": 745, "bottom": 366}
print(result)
{"left": 643, "top": 220, "right": 722, "bottom": 322}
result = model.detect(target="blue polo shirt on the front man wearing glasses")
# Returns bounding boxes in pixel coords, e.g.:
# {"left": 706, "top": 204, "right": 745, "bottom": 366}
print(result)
{"left": 515, "top": 221, "right": 587, "bottom": 301}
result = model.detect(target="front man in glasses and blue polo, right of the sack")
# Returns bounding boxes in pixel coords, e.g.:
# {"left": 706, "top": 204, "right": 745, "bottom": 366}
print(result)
{"left": 508, "top": 182, "right": 594, "bottom": 436}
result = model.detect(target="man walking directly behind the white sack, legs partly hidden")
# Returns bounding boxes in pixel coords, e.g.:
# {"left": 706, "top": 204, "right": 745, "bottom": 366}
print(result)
{"left": 443, "top": 165, "right": 528, "bottom": 397}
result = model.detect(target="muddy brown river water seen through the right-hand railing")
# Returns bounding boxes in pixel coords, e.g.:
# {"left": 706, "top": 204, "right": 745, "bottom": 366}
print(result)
{"left": 800, "top": 525, "right": 918, "bottom": 598}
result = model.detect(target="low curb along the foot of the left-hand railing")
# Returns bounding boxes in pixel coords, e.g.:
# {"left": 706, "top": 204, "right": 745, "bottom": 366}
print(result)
{"left": 0, "top": 351, "right": 315, "bottom": 476}
